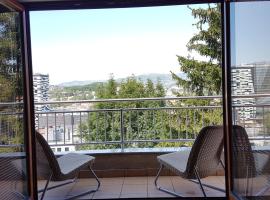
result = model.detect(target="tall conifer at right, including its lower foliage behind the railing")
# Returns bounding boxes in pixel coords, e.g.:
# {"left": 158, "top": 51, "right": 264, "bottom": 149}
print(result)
{"left": 167, "top": 4, "right": 222, "bottom": 148}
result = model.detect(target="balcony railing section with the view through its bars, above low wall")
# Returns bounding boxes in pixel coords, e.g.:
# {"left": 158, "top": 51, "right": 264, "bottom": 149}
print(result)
{"left": 35, "top": 95, "right": 270, "bottom": 153}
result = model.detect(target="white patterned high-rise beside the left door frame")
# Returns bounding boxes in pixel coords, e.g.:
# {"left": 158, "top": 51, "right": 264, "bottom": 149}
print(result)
{"left": 33, "top": 74, "right": 49, "bottom": 112}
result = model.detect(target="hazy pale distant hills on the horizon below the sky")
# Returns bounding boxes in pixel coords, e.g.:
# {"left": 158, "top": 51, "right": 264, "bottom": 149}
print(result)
{"left": 57, "top": 73, "right": 184, "bottom": 88}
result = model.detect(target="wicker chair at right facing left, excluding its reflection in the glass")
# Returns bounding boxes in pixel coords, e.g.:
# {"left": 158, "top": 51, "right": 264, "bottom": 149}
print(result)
{"left": 154, "top": 126, "right": 224, "bottom": 197}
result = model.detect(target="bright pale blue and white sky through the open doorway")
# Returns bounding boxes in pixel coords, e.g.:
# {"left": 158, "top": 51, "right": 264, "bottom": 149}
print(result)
{"left": 30, "top": 5, "right": 201, "bottom": 84}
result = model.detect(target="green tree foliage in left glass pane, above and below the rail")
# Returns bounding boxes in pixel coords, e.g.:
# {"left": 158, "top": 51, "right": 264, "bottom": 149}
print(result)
{"left": 0, "top": 12, "right": 23, "bottom": 152}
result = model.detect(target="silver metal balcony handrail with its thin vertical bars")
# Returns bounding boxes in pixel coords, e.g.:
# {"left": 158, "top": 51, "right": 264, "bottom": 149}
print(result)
{"left": 0, "top": 94, "right": 270, "bottom": 149}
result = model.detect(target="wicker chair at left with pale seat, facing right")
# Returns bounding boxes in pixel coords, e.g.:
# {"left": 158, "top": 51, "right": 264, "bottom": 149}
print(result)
{"left": 36, "top": 132, "right": 100, "bottom": 200}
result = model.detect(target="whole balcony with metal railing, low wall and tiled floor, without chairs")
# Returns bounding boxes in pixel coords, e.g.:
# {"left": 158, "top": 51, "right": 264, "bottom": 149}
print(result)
{"left": 2, "top": 95, "right": 270, "bottom": 199}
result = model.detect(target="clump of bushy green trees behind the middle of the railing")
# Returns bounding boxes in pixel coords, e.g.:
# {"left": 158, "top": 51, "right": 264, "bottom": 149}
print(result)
{"left": 80, "top": 76, "right": 165, "bottom": 149}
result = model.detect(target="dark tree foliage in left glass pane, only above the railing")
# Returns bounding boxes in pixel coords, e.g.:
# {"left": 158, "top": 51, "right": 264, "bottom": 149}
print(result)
{"left": 0, "top": 13, "right": 22, "bottom": 102}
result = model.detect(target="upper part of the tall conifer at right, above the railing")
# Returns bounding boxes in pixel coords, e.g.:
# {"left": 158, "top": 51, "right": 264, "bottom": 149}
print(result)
{"left": 171, "top": 4, "right": 222, "bottom": 96}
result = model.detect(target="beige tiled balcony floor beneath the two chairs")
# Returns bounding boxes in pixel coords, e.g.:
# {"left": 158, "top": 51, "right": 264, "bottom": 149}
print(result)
{"left": 39, "top": 176, "right": 225, "bottom": 200}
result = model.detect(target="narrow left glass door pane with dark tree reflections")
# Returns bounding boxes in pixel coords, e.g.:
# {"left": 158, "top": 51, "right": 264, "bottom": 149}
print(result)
{"left": 0, "top": 5, "right": 26, "bottom": 199}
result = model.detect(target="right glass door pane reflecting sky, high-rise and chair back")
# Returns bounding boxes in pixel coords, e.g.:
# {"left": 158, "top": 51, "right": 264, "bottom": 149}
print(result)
{"left": 231, "top": 2, "right": 270, "bottom": 198}
